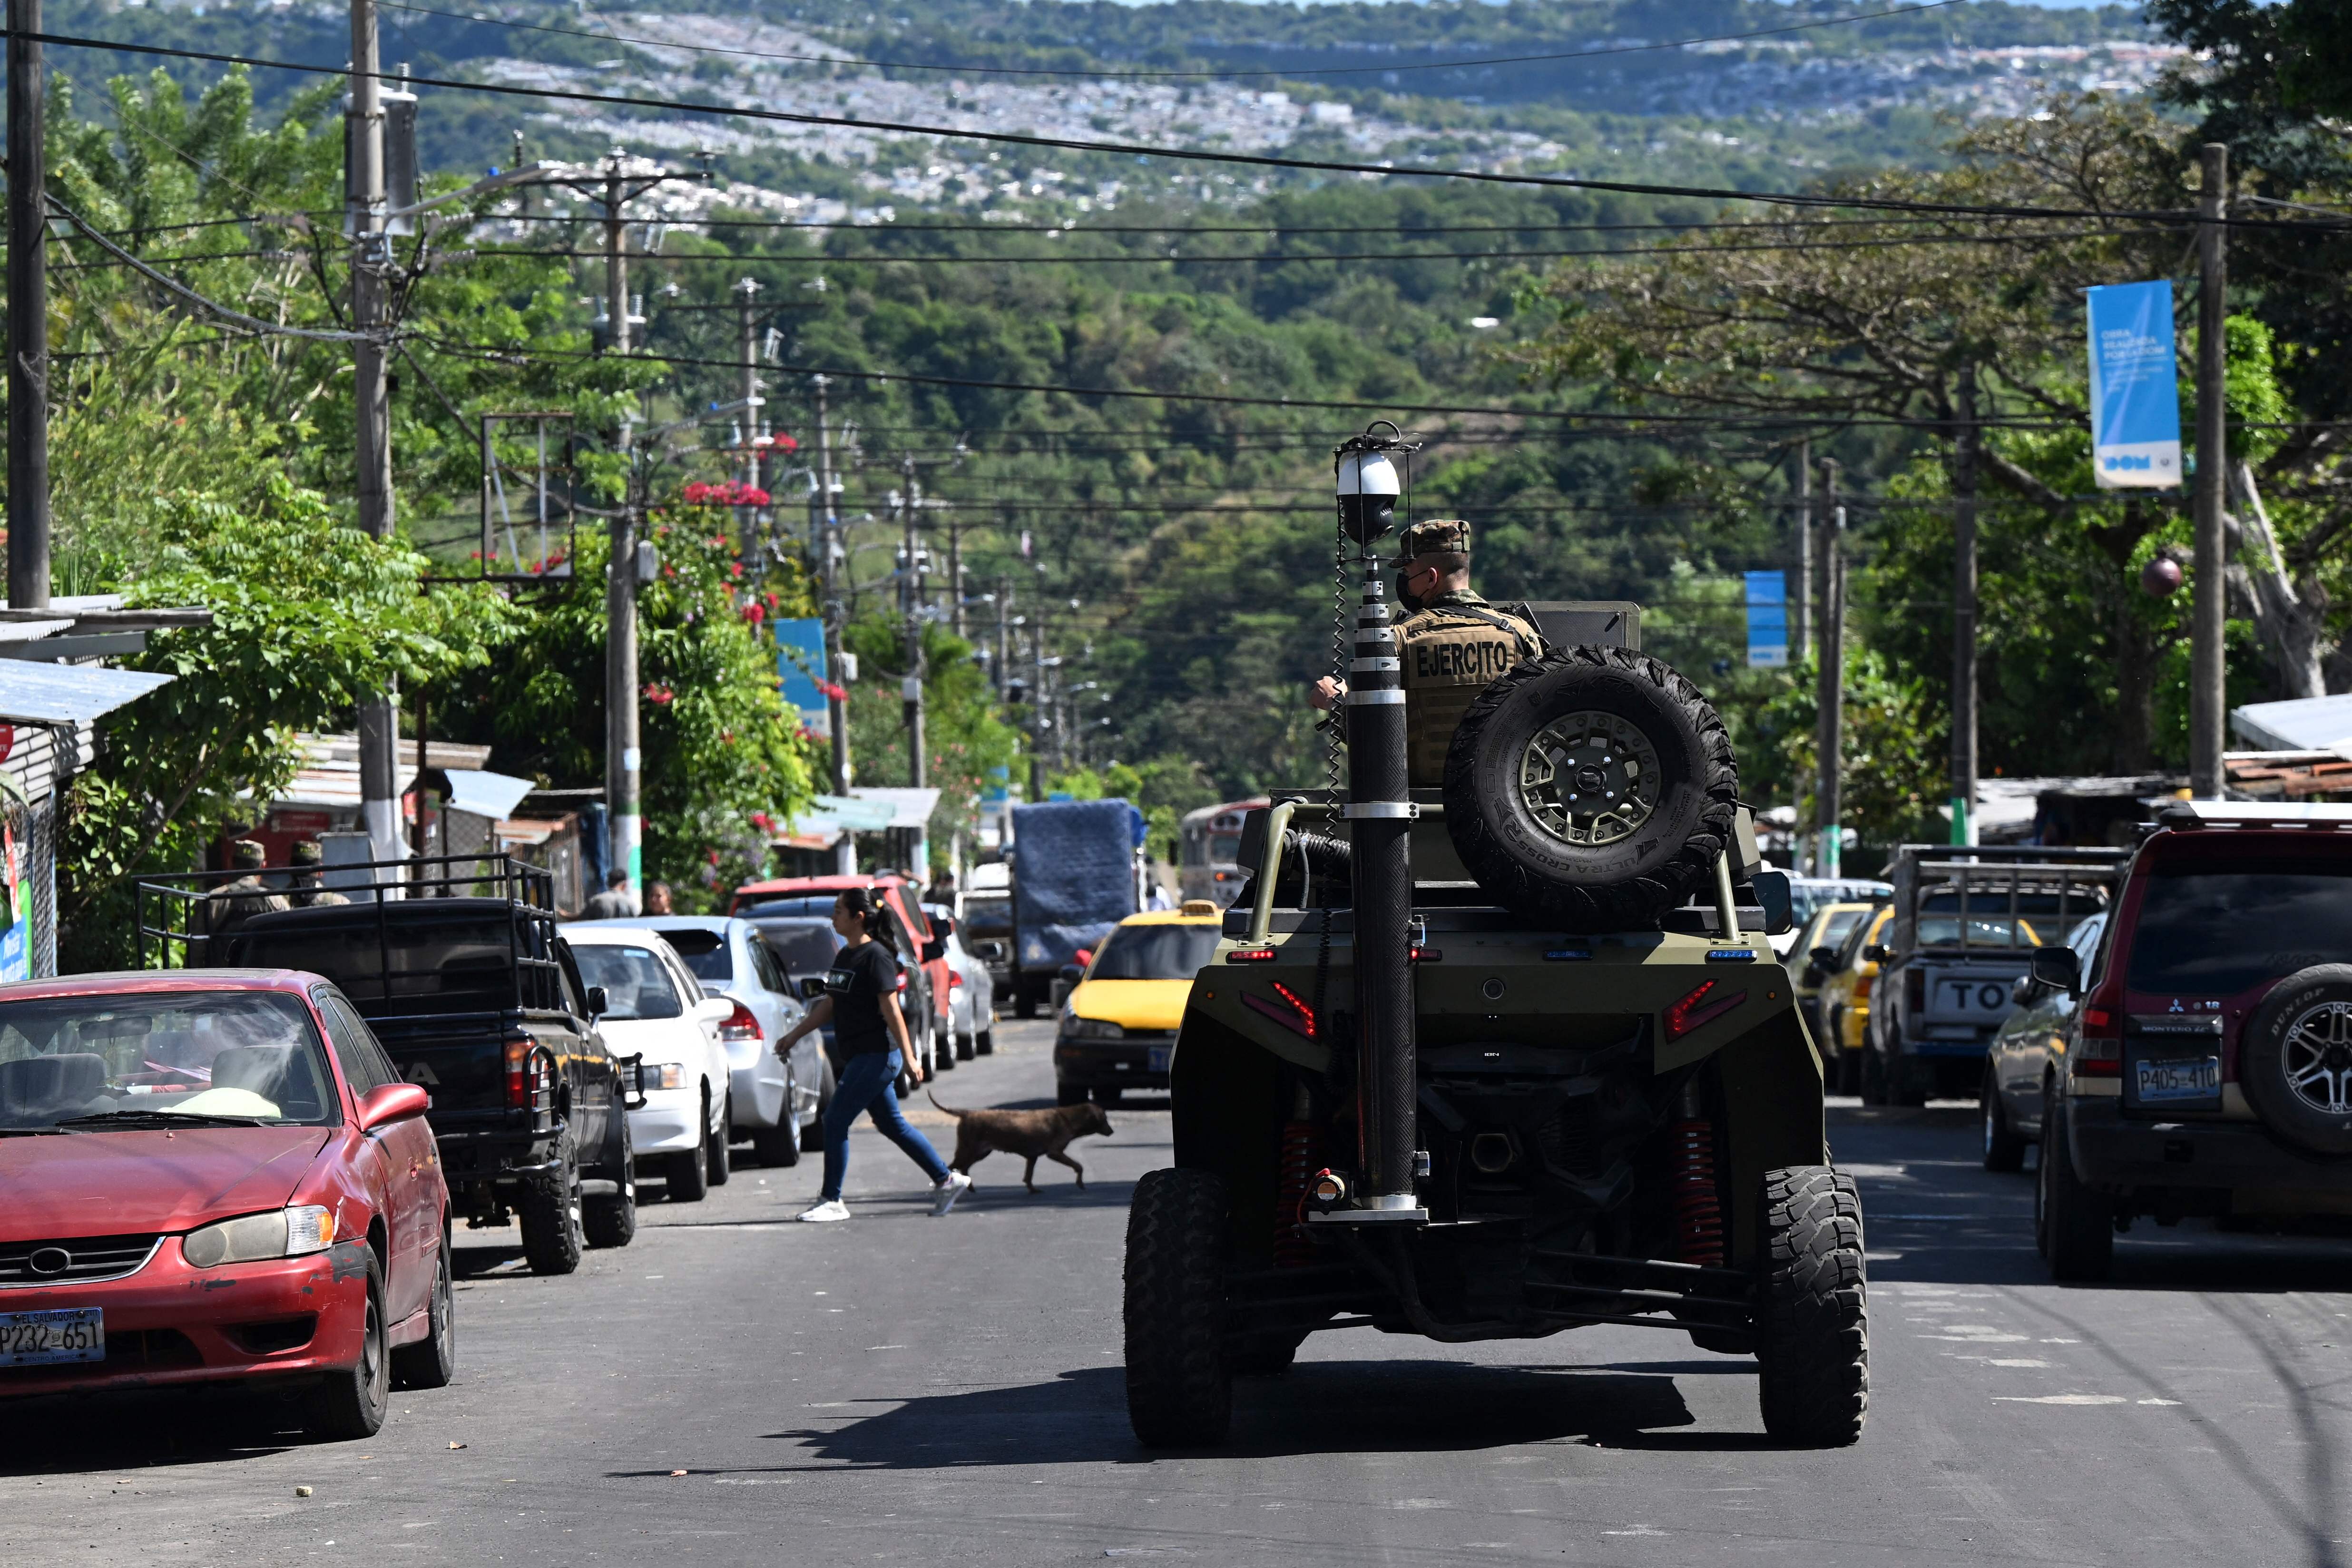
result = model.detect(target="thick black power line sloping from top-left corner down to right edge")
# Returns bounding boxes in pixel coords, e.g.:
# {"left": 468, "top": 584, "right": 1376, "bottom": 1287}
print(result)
{"left": 23, "top": 33, "right": 2258, "bottom": 228}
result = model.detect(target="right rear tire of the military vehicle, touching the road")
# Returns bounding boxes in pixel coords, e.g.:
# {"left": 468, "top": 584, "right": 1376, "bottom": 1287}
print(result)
{"left": 1757, "top": 1166, "right": 1870, "bottom": 1448}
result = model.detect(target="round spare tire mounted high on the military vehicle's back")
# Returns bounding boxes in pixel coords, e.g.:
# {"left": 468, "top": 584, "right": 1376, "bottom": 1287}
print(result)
{"left": 1444, "top": 649, "right": 1741, "bottom": 931}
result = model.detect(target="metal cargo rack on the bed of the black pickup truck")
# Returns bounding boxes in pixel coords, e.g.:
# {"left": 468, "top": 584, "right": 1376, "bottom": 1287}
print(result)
{"left": 132, "top": 853, "right": 567, "bottom": 1018}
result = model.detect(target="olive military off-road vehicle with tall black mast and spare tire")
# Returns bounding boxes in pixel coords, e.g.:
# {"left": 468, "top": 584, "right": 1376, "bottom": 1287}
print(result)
{"left": 1124, "top": 425, "right": 1870, "bottom": 1446}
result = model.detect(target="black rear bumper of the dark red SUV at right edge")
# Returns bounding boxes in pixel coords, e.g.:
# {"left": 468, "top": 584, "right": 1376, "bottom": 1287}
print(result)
{"left": 2065, "top": 1096, "right": 2352, "bottom": 1213}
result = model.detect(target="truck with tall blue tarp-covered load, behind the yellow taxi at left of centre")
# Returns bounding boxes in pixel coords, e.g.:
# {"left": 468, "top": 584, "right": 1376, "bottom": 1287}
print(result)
{"left": 1004, "top": 799, "right": 1143, "bottom": 1018}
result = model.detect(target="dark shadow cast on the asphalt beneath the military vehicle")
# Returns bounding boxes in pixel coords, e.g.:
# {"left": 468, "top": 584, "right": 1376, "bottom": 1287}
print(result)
{"left": 686, "top": 1361, "right": 1722, "bottom": 1476}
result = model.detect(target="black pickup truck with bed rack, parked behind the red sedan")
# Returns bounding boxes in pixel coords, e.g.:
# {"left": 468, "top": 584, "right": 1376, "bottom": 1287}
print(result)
{"left": 139, "top": 856, "right": 637, "bottom": 1274}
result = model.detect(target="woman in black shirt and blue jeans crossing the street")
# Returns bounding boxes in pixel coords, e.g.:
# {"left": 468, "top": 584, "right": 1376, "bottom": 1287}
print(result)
{"left": 776, "top": 889, "right": 971, "bottom": 1225}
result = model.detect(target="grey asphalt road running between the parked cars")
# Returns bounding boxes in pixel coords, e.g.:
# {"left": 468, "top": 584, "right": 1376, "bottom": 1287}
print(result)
{"left": 0, "top": 1025, "right": 2352, "bottom": 1568}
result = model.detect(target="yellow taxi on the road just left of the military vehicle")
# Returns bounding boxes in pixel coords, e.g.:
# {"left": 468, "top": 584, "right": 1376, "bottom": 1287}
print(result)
{"left": 1054, "top": 898, "right": 1223, "bottom": 1105}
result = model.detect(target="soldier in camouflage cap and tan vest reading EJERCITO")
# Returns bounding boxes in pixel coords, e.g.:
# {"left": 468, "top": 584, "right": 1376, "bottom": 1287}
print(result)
{"left": 1308, "top": 517, "right": 1543, "bottom": 790}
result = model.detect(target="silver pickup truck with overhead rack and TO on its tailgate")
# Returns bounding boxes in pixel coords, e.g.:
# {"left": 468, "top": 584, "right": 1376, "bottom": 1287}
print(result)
{"left": 1863, "top": 844, "right": 2128, "bottom": 1105}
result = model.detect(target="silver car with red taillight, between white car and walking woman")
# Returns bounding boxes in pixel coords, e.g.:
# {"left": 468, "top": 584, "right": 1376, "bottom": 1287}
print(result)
{"left": 616, "top": 914, "right": 833, "bottom": 1166}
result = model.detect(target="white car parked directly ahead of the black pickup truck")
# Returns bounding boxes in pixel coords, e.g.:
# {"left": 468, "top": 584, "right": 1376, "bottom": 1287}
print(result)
{"left": 565, "top": 921, "right": 734, "bottom": 1204}
